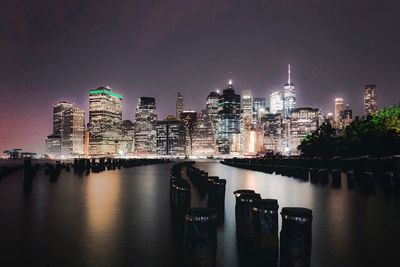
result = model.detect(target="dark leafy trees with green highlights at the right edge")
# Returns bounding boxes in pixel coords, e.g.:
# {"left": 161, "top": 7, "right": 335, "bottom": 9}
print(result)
{"left": 299, "top": 105, "right": 400, "bottom": 157}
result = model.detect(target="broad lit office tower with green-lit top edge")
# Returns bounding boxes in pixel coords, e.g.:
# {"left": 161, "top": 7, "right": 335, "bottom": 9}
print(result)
{"left": 88, "top": 86, "right": 123, "bottom": 157}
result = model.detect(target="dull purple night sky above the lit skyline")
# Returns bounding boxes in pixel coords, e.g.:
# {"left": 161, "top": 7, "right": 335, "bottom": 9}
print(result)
{"left": 0, "top": 0, "right": 400, "bottom": 152}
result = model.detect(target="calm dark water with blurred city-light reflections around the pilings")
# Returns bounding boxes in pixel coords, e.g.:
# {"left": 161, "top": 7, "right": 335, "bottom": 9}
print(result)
{"left": 0, "top": 162, "right": 400, "bottom": 267}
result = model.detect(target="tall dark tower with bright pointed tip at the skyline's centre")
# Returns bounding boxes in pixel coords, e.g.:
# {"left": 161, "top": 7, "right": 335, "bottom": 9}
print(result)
{"left": 217, "top": 80, "right": 240, "bottom": 154}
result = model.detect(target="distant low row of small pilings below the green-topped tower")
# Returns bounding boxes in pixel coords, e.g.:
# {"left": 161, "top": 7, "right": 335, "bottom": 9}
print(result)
{"left": 72, "top": 158, "right": 171, "bottom": 174}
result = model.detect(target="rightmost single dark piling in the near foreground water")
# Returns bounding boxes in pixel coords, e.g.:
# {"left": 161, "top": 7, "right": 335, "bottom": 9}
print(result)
{"left": 280, "top": 208, "right": 312, "bottom": 267}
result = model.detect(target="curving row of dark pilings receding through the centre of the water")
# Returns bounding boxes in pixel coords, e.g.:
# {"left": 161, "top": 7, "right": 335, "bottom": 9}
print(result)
{"left": 170, "top": 162, "right": 226, "bottom": 267}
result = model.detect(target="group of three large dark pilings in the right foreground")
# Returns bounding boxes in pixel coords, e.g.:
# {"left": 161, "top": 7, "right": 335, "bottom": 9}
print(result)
{"left": 234, "top": 190, "right": 312, "bottom": 267}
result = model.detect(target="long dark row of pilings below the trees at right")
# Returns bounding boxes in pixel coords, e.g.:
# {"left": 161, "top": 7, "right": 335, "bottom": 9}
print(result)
{"left": 221, "top": 157, "right": 400, "bottom": 196}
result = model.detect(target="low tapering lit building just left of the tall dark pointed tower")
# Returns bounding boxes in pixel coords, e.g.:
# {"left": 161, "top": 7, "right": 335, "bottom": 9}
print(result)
{"left": 192, "top": 110, "right": 215, "bottom": 157}
